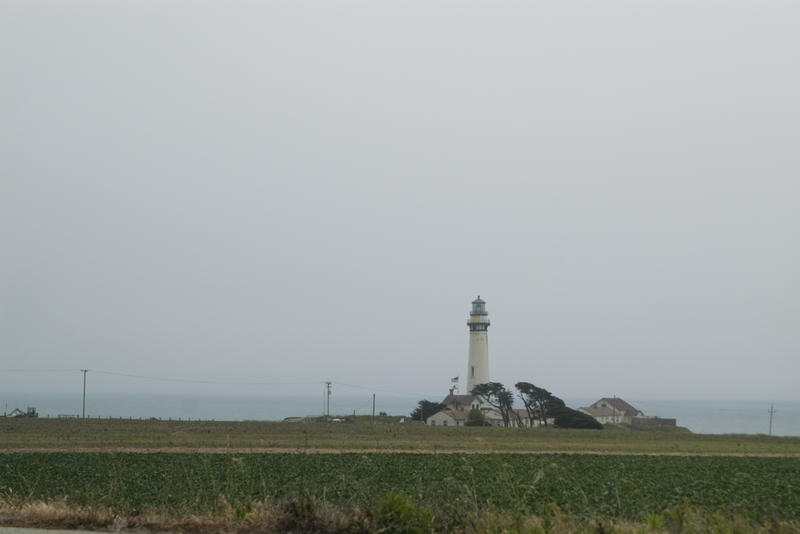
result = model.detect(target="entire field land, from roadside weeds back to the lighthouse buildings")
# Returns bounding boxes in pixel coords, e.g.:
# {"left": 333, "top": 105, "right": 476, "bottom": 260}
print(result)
{"left": 0, "top": 419, "right": 800, "bottom": 534}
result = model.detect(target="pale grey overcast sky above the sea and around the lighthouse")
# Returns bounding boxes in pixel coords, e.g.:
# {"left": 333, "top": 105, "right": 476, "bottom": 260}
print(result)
{"left": 0, "top": 0, "right": 800, "bottom": 400}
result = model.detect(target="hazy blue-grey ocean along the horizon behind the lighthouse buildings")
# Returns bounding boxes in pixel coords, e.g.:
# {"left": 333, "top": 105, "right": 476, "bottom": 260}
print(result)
{"left": 0, "top": 393, "right": 800, "bottom": 436}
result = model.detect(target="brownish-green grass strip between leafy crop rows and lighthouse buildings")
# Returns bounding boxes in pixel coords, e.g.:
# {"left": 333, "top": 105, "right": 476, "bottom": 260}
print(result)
{"left": 0, "top": 418, "right": 800, "bottom": 456}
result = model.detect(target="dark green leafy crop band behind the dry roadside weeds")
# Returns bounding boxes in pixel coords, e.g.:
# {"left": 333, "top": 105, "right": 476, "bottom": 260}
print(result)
{"left": 0, "top": 453, "right": 800, "bottom": 530}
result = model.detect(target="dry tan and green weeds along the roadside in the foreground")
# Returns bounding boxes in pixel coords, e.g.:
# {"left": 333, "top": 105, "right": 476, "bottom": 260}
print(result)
{"left": 6, "top": 502, "right": 800, "bottom": 534}
